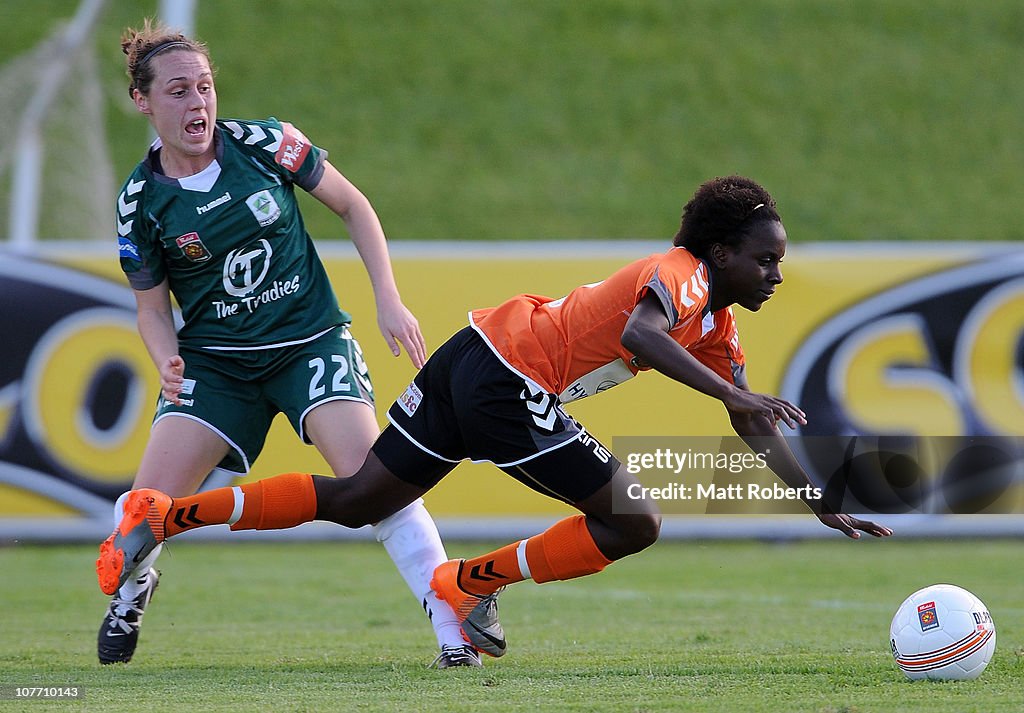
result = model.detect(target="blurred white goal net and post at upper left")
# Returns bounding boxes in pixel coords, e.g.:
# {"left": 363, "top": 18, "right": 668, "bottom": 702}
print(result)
{"left": 0, "top": 0, "right": 117, "bottom": 252}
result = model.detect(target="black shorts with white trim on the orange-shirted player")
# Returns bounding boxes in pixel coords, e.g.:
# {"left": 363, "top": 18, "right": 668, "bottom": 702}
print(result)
{"left": 373, "top": 327, "right": 620, "bottom": 503}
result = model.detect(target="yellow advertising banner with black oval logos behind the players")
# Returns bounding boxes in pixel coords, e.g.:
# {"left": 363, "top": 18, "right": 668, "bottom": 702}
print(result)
{"left": 0, "top": 243, "right": 1024, "bottom": 525}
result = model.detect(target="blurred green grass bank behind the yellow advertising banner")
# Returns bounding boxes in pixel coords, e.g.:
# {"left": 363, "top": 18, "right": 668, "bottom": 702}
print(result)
{"left": 0, "top": 0, "right": 1024, "bottom": 241}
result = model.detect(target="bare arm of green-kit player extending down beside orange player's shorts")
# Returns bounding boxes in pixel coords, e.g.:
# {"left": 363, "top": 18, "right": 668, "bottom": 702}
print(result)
{"left": 310, "top": 162, "right": 427, "bottom": 369}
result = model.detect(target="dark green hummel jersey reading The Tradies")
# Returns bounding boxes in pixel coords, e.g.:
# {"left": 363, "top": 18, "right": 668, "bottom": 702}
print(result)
{"left": 117, "top": 118, "right": 351, "bottom": 350}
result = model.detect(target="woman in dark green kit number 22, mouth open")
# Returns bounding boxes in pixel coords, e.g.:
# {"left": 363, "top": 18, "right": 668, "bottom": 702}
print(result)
{"left": 97, "top": 22, "right": 480, "bottom": 668}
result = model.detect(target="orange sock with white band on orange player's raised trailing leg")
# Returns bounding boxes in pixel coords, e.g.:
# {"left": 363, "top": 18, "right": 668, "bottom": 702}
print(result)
{"left": 164, "top": 473, "right": 316, "bottom": 537}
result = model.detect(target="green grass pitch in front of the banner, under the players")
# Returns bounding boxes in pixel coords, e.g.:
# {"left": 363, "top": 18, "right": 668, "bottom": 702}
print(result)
{"left": 0, "top": 538, "right": 1024, "bottom": 713}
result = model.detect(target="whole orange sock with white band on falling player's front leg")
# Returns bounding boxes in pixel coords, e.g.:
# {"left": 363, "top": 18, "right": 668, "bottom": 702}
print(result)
{"left": 459, "top": 515, "right": 611, "bottom": 596}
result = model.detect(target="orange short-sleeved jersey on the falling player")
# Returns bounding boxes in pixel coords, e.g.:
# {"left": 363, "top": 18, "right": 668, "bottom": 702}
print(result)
{"left": 469, "top": 248, "right": 744, "bottom": 404}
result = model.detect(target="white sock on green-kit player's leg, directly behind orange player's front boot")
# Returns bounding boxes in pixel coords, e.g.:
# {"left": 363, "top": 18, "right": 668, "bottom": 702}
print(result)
{"left": 374, "top": 499, "right": 466, "bottom": 646}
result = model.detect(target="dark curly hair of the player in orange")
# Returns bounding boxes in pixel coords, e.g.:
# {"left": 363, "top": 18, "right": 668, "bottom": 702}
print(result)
{"left": 672, "top": 176, "right": 782, "bottom": 257}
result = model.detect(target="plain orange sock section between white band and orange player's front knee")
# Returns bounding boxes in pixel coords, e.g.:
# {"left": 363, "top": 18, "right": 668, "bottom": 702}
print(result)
{"left": 526, "top": 515, "right": 611, "bottom": 584}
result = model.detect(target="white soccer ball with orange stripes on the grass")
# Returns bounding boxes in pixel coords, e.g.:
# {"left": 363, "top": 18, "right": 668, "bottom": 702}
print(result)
{"left": 889, "top": 584, "right": 995, "bottom": 681}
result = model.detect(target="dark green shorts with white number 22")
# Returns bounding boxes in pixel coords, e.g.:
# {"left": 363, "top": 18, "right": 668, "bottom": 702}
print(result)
{"left": 153, "top": 324, "right": 374, "bottom": 475}
